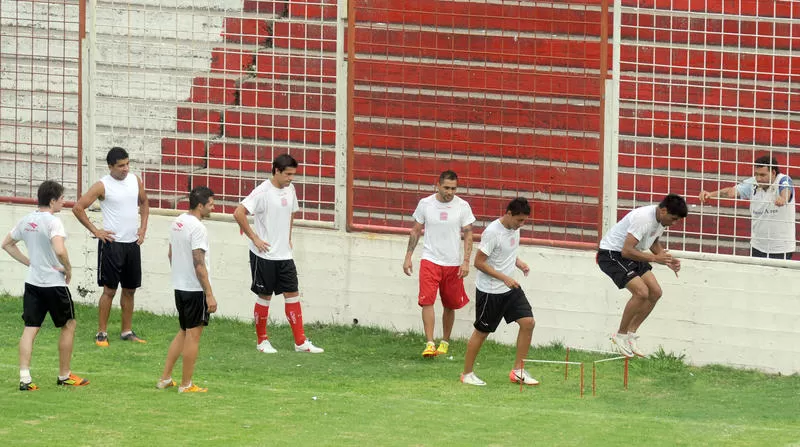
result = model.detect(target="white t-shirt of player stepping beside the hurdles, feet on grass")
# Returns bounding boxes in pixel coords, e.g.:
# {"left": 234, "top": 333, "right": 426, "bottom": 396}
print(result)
{"left": 475, "top": 219, "right": 519, "bottom": 294}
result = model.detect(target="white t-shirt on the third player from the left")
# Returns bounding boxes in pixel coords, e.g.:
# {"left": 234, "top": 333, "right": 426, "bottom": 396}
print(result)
{"left": 169, "top": 213, "right": 211, "bottom": 292}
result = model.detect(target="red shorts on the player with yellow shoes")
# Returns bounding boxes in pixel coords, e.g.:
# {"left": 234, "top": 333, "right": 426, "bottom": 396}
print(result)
{"left": 419, "top": 259, "right": 469, "bottom": 309}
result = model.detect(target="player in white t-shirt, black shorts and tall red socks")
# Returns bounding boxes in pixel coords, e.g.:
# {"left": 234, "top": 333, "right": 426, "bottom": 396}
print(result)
{"left": 233, "top": 154, "right": 324, "bottom": 354}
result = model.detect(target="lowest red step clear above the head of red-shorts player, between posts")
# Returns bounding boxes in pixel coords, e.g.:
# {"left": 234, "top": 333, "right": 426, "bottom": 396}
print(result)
{"left": 353, "top": 118, "right": 600, "bottom": 165}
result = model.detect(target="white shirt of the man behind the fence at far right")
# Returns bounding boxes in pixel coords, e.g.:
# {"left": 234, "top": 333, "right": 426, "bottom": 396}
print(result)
{"left": 736, "top": 174, "right": 797, "bottom": 253}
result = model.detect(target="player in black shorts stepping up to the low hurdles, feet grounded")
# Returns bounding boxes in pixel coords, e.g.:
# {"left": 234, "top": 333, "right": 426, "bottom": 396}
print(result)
{"left": 461, "top": 197, "right": 539, "bottom": 385}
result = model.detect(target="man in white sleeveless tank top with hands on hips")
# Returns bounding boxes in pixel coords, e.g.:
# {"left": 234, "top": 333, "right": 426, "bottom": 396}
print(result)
{"left": 72, "top": 147, "right": 150, "bottom": 347}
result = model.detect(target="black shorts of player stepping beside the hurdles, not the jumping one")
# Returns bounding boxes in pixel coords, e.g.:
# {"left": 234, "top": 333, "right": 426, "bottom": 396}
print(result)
{"left": 473, "top": 287, "right": 533, "bottom": 332}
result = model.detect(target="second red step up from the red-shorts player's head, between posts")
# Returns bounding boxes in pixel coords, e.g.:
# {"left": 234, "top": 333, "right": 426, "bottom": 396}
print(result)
{"left": 353, "top": 90, "right": 600, "bottom": 132}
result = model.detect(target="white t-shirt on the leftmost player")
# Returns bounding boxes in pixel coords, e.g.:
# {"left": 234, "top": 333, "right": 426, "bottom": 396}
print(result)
{"left": 9, "top": 211, "right": 67, "bottom": 287}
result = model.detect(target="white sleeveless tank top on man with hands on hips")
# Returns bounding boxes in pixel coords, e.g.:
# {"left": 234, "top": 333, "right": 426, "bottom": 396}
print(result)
{"left": 100, "top": 173, "right": 139, "bottom": 242}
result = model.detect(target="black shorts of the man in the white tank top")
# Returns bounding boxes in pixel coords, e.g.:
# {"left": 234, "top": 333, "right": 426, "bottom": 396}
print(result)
{"left": 97, "top": 240, "right": 142, "bottom": 289}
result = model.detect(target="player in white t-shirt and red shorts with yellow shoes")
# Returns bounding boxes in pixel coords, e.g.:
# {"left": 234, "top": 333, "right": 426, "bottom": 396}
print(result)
{"left": 403, "top": 171, "right": 475, "bottom": 357}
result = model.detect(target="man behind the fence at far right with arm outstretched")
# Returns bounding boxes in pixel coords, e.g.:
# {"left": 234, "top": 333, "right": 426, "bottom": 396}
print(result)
{"left": 700, "top": 155, "right": 797, "bottom": 259}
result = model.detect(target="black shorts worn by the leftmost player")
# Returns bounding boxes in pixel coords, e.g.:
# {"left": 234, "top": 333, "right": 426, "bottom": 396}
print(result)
{"left": 22, "top": 283, "right": 75, "bottom": 327}
